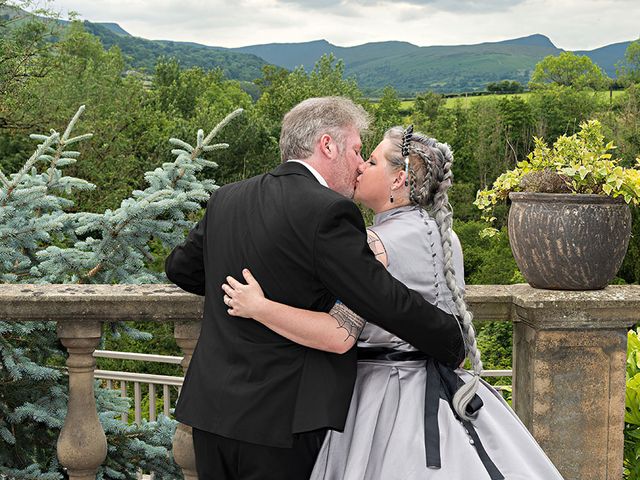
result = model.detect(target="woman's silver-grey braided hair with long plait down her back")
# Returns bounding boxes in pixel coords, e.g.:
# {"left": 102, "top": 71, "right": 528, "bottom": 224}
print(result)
{"left": 384, "top": 127, "right": 482, "bottom": 419}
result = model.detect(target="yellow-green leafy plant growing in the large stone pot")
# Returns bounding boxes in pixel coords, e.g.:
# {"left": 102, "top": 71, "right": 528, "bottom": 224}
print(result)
{"left": 474, "top": 120, "right": 640, "bottom": 236}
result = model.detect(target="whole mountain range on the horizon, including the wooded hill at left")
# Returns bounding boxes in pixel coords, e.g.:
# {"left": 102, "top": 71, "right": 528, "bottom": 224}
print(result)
{"left": 0, "top": 6, "right": 631, "bottom": 95}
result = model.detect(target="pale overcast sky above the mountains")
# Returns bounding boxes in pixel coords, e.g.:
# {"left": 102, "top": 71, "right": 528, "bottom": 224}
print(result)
{"left": 42, "top": 0, "right": 640, "bottom": 50}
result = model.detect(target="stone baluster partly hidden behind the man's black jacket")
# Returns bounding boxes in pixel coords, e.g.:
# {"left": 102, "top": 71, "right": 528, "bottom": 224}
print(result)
{"left": 173, "top": 321, "right": 201, "bottom": 480}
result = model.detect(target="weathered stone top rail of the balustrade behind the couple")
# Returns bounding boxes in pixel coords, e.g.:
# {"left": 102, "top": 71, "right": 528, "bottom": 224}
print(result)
{"left": 0, "top": 284, "right": 640, "bottom": 328}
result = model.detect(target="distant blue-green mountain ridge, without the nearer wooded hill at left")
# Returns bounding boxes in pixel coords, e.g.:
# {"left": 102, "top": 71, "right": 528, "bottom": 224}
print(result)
{"left": 235, "top": 35, "right": 629, "bottom": 96}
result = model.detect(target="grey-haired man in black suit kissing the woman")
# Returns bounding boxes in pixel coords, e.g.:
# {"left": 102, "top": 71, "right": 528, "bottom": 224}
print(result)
{"left": 165, "top": 97, "right": 463, "bottom": 480}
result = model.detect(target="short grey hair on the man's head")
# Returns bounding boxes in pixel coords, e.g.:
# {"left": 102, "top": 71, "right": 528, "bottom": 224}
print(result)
{"left": 280, "top": 97, "right": 369, "bottom": 162}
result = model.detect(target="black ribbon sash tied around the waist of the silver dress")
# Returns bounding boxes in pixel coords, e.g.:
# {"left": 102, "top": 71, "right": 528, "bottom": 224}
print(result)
{"left": 358, "top": 347, "right": 504, "bottom": 480}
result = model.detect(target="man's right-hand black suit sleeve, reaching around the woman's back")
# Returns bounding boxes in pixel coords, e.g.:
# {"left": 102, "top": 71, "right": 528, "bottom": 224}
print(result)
{"left": 314, "top": 199, "right": 464, "bottom": 366}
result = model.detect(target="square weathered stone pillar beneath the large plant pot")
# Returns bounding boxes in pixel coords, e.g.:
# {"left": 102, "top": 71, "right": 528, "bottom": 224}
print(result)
{"left": 513, "top": 286, "right": 637, "bottom": 480}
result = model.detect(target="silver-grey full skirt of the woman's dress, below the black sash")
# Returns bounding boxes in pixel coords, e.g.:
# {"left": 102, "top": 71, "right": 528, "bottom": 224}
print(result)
{"left": 311, "top": 360, "right": 562, "bottom": 480}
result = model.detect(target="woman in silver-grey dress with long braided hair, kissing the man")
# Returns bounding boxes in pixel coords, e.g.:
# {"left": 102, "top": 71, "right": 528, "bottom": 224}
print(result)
{"left": 223, "top": 127, "right": 562, "bottom": 480}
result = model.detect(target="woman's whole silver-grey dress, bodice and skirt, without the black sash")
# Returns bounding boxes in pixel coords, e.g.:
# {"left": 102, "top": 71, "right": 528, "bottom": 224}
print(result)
{"left": 311, "top": 207, "right": 562, "bottom": 480}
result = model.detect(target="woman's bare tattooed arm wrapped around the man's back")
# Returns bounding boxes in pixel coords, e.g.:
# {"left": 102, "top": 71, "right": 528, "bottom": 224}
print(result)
{"left": 222, "top": 232, "right": 387, "bottom": 353}
